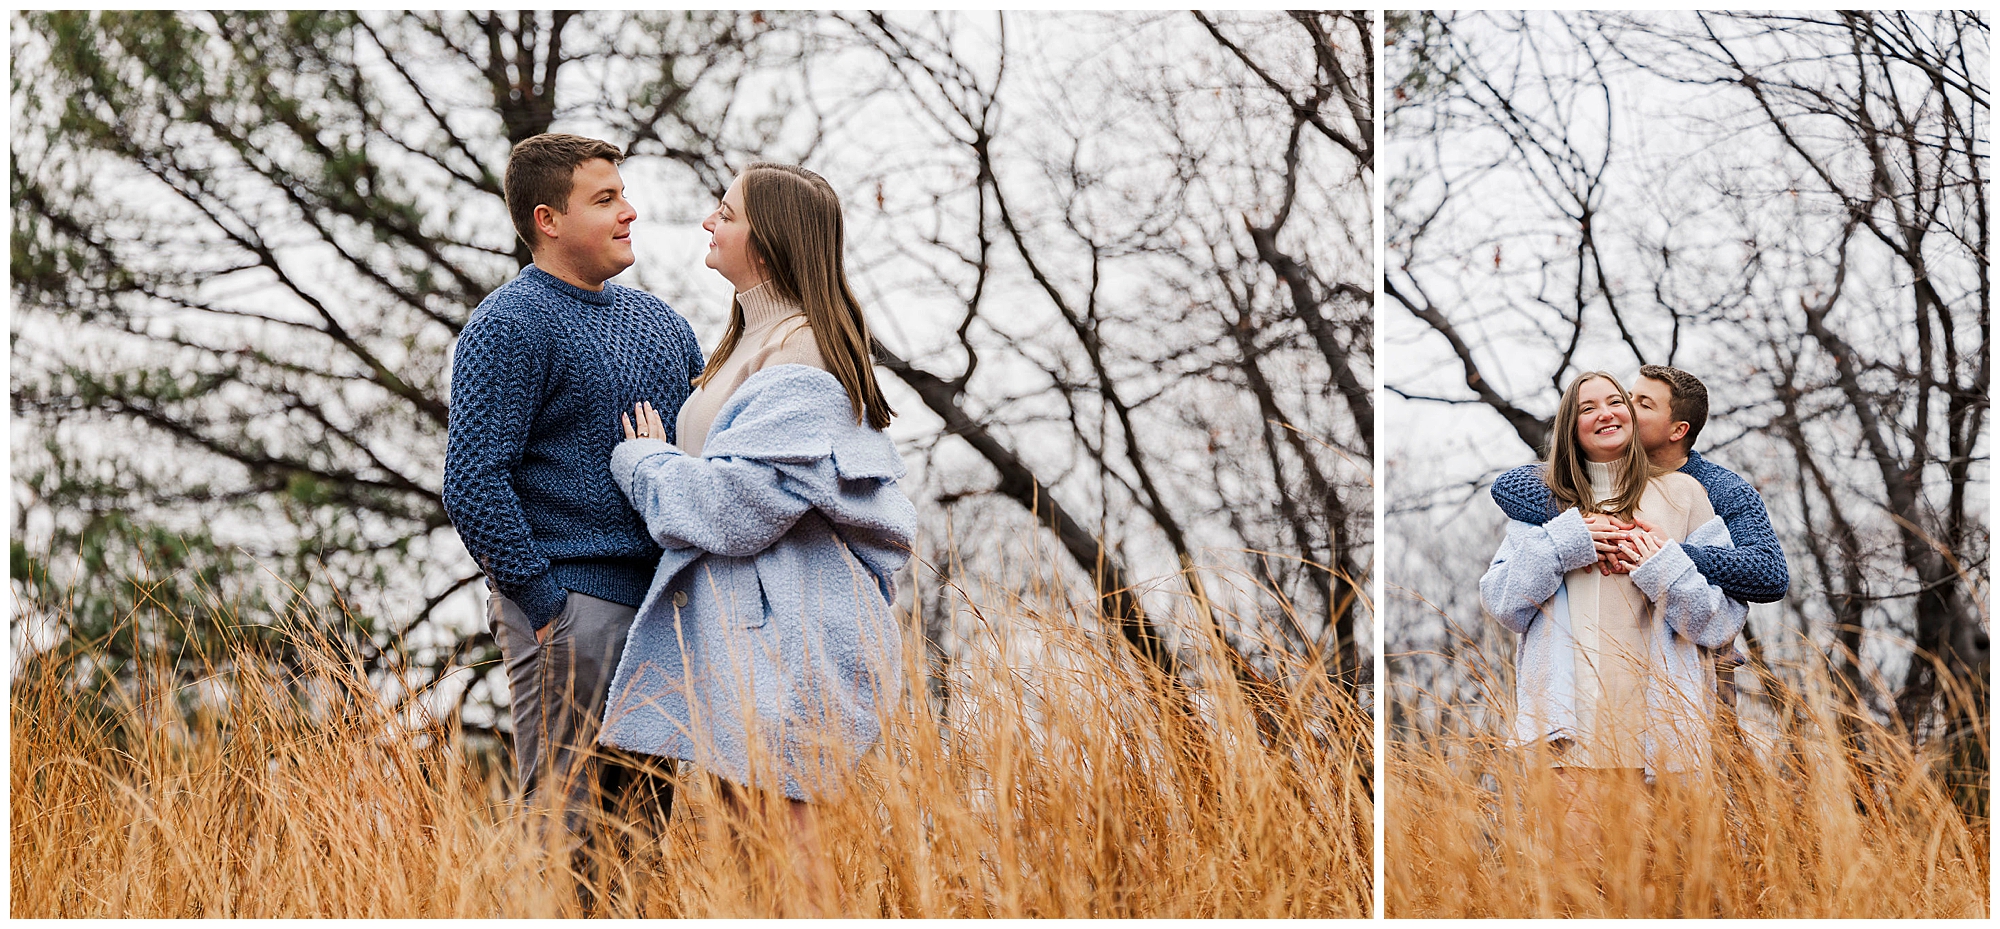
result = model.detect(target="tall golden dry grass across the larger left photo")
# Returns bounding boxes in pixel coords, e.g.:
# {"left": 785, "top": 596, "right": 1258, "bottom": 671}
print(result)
{"left": 8, "top": 568, "right": 1372, "bottom": 917}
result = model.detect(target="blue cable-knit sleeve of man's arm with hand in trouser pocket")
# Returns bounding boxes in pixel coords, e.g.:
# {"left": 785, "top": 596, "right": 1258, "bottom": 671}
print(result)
{"left": 444, "top": 314, "right": 568, "bottom": 629}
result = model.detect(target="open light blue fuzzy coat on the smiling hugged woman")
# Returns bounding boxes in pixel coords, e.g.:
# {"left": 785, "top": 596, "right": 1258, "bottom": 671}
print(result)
{"left": 1480, "top": 509, "right": 1750, "bottom": 777}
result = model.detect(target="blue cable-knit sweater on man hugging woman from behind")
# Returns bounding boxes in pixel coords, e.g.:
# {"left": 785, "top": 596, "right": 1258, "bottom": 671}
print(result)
{"left": 1492, "top": 452, "right": 1792, "bottom": 603}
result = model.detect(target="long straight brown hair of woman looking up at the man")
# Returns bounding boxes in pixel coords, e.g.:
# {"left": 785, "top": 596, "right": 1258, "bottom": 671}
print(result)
{"left": 696, "top": 162, "right": 896, "bottom": 428}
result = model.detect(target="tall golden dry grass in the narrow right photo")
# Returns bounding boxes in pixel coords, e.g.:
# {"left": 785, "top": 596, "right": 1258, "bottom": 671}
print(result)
{"left": 1384, "top": 648, "right": 1990, "bottom": 917}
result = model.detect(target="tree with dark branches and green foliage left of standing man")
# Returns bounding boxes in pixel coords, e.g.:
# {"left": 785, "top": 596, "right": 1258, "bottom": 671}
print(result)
{"left": 10, "top": 12, "right": 796, "bottom": 728}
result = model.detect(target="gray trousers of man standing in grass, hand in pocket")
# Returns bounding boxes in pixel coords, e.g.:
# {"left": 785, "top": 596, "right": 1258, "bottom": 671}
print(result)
{"left": 486, "top": 591, "right": 674, "bottom": 868}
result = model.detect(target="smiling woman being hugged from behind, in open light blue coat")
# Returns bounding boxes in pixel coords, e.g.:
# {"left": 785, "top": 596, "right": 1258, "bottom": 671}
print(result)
{"left": 1480, "top": 372, "right": 1748, "bottom": 840}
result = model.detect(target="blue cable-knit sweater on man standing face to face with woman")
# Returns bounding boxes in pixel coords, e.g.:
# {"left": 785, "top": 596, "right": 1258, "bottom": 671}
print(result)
{"left": 444, "top": 264, "right": 702, "bottom": 629}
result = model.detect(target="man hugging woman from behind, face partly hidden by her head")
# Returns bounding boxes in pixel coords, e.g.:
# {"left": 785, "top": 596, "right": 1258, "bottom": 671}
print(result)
{"left": 1492, "top": 364, "right": 1792, "bottom": 603}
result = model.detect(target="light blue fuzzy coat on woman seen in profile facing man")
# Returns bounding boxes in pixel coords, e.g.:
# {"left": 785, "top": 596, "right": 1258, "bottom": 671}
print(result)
{"left": 598, "top": 364, "right": 916, "bottom": 801}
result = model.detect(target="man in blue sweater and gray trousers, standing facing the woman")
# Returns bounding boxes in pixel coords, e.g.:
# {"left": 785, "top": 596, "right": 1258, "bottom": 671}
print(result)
{"left": 444, "top": 132, "right": 702, "bottom": 868}
